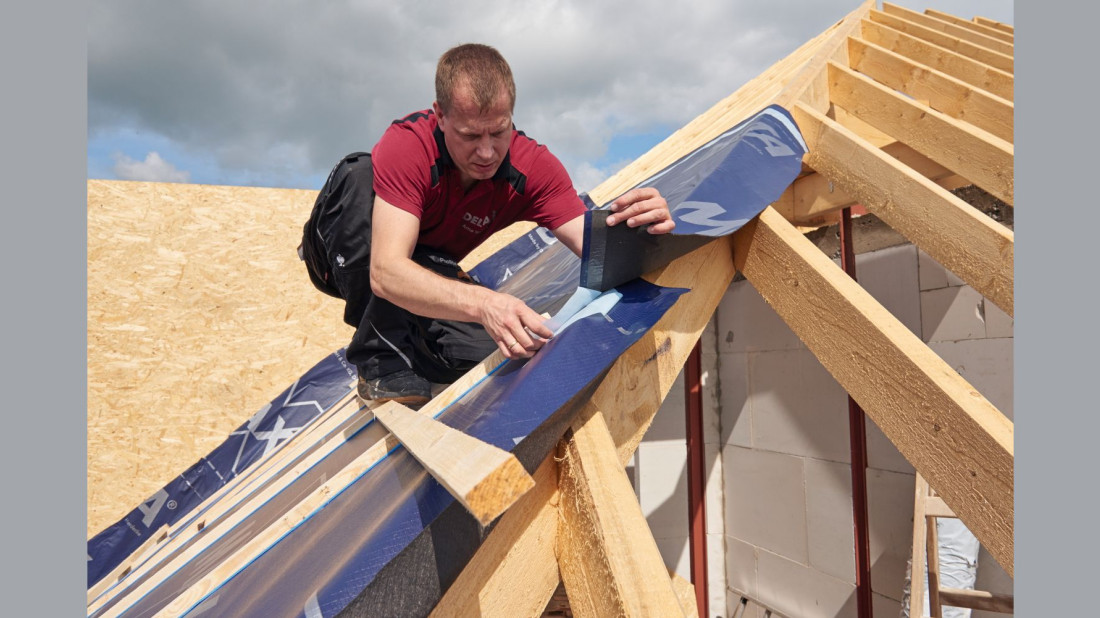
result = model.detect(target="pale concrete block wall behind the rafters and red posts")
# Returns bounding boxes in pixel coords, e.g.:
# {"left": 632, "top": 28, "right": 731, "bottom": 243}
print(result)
{"left": 712, "top": 240, "right": 1012, "bottom": 617}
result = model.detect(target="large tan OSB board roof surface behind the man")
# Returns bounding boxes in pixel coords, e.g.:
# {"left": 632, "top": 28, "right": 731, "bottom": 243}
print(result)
{"left": 88, "top": 180, "right": 352, "bottom": 538}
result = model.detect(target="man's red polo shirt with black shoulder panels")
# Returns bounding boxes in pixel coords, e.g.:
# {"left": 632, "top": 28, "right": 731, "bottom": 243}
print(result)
{"left": 371, "top": 110, "right": 585, "bottom": 260}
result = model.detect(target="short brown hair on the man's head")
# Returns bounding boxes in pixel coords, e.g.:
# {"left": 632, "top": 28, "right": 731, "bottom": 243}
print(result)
{"left": 436, "top": 43, "right": 516, "bottom": 112}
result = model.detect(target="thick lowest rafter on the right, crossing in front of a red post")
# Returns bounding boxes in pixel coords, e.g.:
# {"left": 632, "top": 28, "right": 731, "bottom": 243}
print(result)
{"left": 733, "top": 205, "right": 1014, "bottom": 575}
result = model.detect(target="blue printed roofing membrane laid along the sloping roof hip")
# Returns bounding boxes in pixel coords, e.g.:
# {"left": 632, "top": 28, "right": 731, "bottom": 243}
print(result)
{"left": 88, "top": 106, "right": 806, "bottom": 618}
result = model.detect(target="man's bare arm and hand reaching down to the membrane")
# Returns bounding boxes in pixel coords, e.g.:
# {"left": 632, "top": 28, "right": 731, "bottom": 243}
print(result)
{"left": 371, "top": 192, "right": 553, "bottom": 358}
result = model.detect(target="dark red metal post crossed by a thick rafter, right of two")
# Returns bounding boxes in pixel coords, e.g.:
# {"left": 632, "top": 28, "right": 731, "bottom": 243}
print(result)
{"left": 840, "top": 208, "right": 873, "bottom": 618}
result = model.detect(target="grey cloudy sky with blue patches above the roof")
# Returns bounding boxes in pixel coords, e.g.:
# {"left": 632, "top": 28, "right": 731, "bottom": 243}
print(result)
{"left": 88, "top": 0, "right": 1014, "bottom": 190}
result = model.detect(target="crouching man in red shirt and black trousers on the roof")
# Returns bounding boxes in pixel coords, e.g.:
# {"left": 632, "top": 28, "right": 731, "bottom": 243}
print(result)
{"left": 299, "top": 44, "right": 675, "bottom": 406}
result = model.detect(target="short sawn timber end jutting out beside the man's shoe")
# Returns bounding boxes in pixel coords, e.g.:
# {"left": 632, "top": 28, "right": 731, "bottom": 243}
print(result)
{"left": 374, "top": 395, "right": 535, "bottom": 526}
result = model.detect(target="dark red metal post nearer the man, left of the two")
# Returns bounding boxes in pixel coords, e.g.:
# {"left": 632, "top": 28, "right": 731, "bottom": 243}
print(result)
{"left": 684, "top": 341, "right": 710, "bottom": 618}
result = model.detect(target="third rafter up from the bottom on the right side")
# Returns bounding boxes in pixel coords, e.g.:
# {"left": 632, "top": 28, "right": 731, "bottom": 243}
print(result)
{"left": 828, "top": 58, "right": 1014, "bottom": 203}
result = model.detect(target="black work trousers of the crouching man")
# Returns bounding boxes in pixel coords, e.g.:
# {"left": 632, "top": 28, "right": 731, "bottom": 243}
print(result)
{"left": 299, "top": 153, "right": 496, "bottom": 384}
